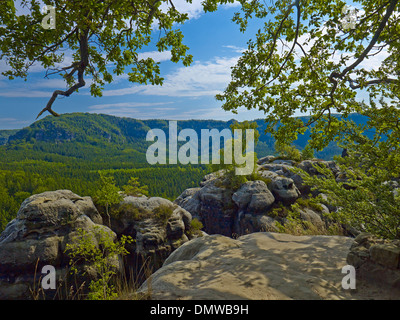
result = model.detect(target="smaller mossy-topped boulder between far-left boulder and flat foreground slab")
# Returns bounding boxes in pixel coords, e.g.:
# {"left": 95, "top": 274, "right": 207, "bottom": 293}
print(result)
{"left": 111, "top": 196, "right": 192, "bottom": 282}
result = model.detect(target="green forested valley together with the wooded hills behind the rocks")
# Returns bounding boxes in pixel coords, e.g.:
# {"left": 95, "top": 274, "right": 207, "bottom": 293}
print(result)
{"left": 0, "top": 113, "right": 359, "bottom": 230}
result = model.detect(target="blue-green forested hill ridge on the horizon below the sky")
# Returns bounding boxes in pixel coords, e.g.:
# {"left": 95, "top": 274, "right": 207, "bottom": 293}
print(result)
{"left": 0, "top": 113, "right": 365, "bottom": 163}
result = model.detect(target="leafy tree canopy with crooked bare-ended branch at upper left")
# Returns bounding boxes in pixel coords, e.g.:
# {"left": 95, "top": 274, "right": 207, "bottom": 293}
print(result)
{"left": 0, "top": 0, "right": 233, "bottom": 117}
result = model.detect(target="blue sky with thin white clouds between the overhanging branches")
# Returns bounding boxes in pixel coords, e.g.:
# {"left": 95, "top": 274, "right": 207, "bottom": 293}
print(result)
{"left": 0, "top": 0, "right": 272, "bottom": 129}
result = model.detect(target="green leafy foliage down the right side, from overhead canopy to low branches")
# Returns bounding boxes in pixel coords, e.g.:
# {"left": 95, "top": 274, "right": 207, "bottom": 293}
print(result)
{"left": 217, "top": 0, "right": 400, "bottom": 238}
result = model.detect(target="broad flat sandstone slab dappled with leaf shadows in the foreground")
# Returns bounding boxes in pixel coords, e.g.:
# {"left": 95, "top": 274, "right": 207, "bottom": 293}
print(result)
{"left": 139, "top": 232, "right": 398, "bottom": 300}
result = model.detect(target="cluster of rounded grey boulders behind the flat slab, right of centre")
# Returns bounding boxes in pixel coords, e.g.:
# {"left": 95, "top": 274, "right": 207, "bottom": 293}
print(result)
{"left": 174, "top": 156, "right": 340, "bottom": 237}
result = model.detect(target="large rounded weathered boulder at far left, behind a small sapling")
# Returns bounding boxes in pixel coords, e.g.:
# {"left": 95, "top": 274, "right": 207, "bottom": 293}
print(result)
{"left": 0, "top": 190, "right": 114, "bottom": 299}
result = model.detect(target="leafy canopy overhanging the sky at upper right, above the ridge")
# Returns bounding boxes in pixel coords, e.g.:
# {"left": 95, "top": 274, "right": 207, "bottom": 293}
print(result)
{"left": 217, "top": 0, "right": 400, "bottom": 149}
